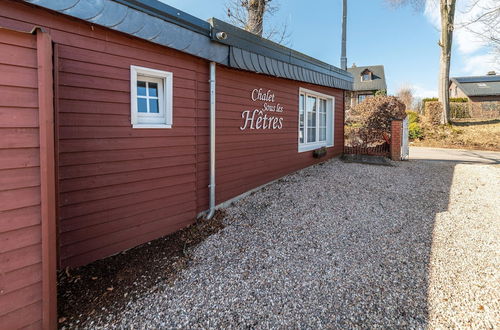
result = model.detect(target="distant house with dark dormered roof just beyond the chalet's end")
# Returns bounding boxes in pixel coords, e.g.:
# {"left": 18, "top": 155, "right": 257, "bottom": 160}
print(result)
{"left": 346, "top": 64, "right": 387, "bottom": 107}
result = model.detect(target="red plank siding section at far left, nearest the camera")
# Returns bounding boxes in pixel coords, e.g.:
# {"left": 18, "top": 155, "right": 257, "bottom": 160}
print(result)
{"left": 0, "top": 29, "right": 42, "bottom": 329}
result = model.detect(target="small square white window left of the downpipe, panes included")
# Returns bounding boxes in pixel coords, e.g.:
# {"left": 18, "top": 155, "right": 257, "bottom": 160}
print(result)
{"left": 130, "top": 66, "right": 173, "bottom": 128}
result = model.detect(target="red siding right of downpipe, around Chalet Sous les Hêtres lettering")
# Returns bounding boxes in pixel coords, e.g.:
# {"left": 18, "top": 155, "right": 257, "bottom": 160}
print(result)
{"left": 197, "top": 66, "right": 344, "bottom": 206}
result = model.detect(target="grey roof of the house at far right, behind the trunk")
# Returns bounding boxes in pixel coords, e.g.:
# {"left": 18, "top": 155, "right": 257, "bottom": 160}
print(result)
{"left": 451, "top": 75, "right": 500, "bottom": 97}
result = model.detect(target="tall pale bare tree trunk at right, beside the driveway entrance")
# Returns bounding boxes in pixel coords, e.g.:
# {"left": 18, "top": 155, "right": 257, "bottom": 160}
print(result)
{"left": 387, "top": 0, "right": 456, "bottom": 124}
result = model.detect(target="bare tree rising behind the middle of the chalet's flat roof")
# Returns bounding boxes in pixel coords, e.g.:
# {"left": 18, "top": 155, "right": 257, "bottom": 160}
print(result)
{"left": 226, "top": 0, "right": 290, "bottom": 44}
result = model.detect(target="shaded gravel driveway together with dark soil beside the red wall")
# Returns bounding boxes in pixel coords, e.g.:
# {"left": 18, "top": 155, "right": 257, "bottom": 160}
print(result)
{"left": 59, "top": 160, "right": 454, "bottom": 328}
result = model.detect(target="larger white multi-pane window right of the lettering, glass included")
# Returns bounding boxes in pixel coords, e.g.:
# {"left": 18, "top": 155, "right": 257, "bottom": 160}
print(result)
{"left": 299, "top": 88, "right": 335, "bottom": 152}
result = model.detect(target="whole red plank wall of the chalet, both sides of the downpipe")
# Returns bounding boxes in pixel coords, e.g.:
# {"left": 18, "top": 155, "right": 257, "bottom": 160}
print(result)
{"left": 0, "top": 0, "right": 343, "bottom": 267}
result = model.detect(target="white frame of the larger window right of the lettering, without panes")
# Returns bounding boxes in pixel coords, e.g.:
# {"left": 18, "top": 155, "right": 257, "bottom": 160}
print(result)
{"left": 297, "top": 88, "right": 335, "bottom": 152}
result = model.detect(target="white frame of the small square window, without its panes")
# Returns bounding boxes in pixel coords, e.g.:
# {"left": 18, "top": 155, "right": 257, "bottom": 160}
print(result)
{"left": 130, "top": 65, "right": 174, "bottom": 128}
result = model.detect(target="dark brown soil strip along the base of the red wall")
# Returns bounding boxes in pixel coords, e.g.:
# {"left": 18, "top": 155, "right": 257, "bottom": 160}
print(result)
{"left": 58, "top": 211, "right": 225, "bottom": 328}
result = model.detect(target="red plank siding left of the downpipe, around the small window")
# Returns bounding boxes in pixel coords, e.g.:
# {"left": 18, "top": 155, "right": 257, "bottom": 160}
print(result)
{"left": 0, "top": 1, "right": 208, "bottom": 267}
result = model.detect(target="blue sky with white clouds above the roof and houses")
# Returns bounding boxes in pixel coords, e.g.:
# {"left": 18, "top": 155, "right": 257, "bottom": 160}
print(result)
{"left": 162, "top": 0, "right": 499, "bottom": 97}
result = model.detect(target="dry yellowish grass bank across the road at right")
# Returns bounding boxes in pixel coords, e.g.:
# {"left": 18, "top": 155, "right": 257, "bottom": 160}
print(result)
{"left": 411, "top": 119, "right": 500, "bottom": 151}
